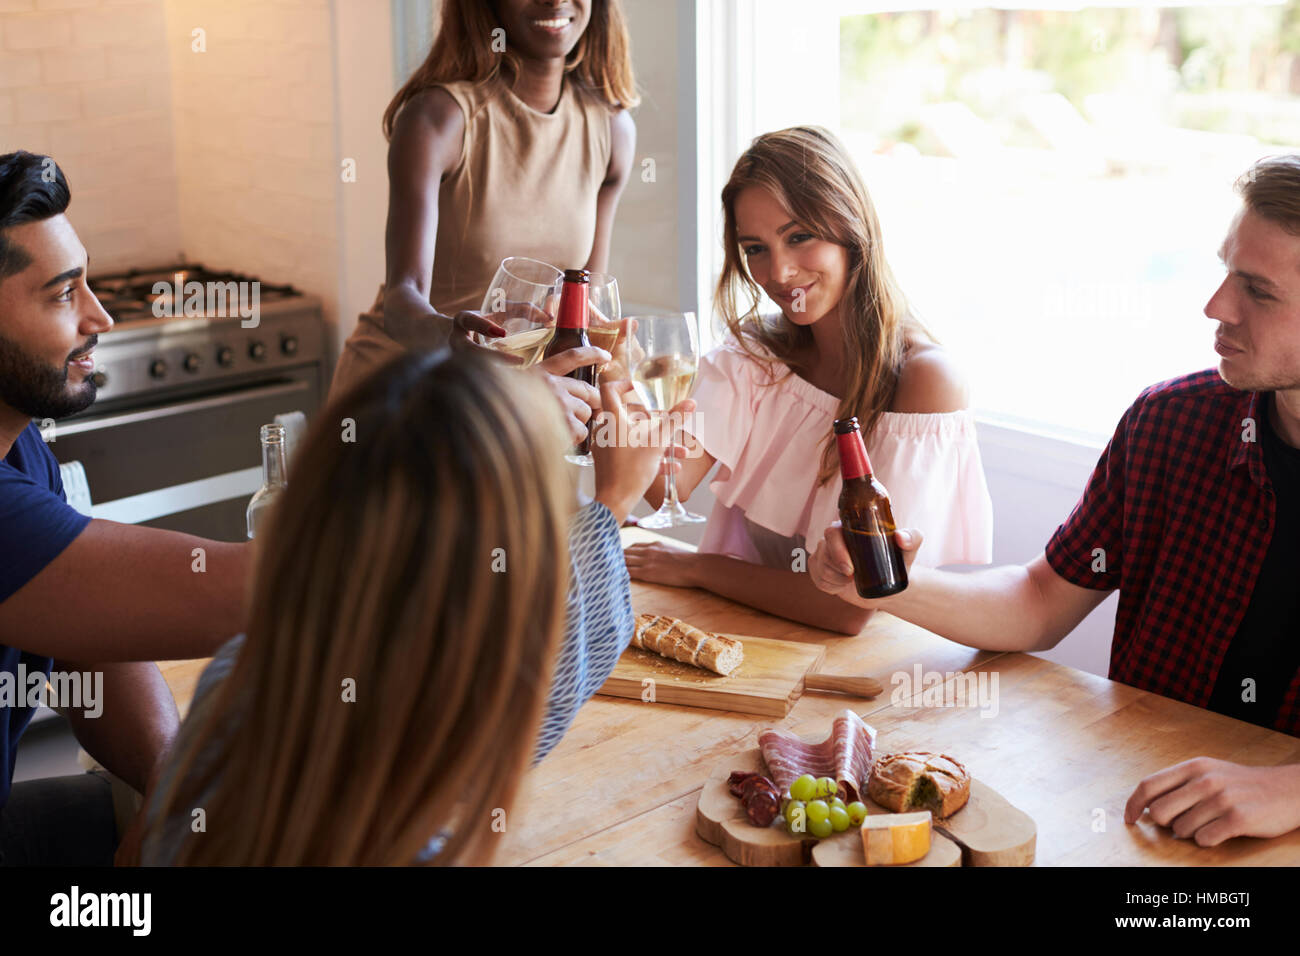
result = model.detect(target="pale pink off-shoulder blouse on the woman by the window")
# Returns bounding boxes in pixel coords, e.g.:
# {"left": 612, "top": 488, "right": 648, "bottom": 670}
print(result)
{"left": 692, "top": 339, "right": 993, "bottom": 568}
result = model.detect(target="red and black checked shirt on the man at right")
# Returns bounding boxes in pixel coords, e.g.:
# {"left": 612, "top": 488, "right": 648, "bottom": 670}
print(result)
{"left": 1047, "top": 369, "right": 1300, "bottom": 736}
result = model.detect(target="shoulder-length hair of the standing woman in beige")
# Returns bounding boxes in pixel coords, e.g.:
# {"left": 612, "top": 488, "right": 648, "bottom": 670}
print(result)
{"left": 384, "top": 0, "right": 641, "bottom": 138}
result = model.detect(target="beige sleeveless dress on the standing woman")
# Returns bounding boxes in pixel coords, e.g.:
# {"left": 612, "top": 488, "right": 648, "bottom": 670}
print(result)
{"left": 330, "top": 77, "right": 611, "bottom": 395}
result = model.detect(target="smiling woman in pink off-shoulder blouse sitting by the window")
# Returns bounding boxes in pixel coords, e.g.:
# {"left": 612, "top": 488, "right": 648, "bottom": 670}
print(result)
{"left": 624, "top": 126, "right": 993, "bottom": 633}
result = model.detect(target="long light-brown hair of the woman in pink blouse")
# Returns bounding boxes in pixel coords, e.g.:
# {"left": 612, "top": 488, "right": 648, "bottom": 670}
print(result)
{"left": 714, "top": 126, "right": 933, "bottom": 484}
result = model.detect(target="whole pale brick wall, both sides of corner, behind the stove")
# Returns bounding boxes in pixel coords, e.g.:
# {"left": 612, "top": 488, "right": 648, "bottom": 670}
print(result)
{"left": 0, "top": 0, "right": 345, "bottom": 321}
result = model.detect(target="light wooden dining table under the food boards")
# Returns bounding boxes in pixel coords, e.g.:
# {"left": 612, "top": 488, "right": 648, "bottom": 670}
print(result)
{"left": 159, "top": 528, "right": 1300, "bottom": 866}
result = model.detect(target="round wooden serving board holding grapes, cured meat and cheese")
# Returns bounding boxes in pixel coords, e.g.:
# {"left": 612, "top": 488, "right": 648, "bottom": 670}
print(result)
{"left": 696, "top": 747, "right": 1037, "bottom": 866}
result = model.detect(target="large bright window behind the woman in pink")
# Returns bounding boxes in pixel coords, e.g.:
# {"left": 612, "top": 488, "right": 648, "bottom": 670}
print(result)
{"left": 697, "top": 0, "right": 1300, "bottom": 444}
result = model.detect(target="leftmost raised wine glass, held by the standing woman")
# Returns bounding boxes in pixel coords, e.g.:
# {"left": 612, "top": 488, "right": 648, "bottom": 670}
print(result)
{"left": 478, "top": 256, "right": 564, "bottom": 368}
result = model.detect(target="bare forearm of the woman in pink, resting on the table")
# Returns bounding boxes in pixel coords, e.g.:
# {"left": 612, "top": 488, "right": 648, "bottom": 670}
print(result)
{"left": 690, "top": 553, "right": 871, "bottom": 635}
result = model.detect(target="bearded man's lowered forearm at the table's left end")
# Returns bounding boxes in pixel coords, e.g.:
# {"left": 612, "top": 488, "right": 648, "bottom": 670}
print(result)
{"left": 55, "top": 661, "right": 181, "bottom": 793}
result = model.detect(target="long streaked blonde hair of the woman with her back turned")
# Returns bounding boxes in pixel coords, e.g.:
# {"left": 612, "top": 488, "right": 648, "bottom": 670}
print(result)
{"left": 144, "top": 350, "right": 576, "bottom": 865}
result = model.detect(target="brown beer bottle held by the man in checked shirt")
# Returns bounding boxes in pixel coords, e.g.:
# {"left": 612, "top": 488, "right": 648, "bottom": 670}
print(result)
{"left": 835, "top": 418, "right": 907, "bottom": 598}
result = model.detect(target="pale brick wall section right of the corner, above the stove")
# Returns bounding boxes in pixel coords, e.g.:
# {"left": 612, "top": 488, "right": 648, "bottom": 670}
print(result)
{"left": 166, "top": 0, "right": 340, "bottom": 332}
